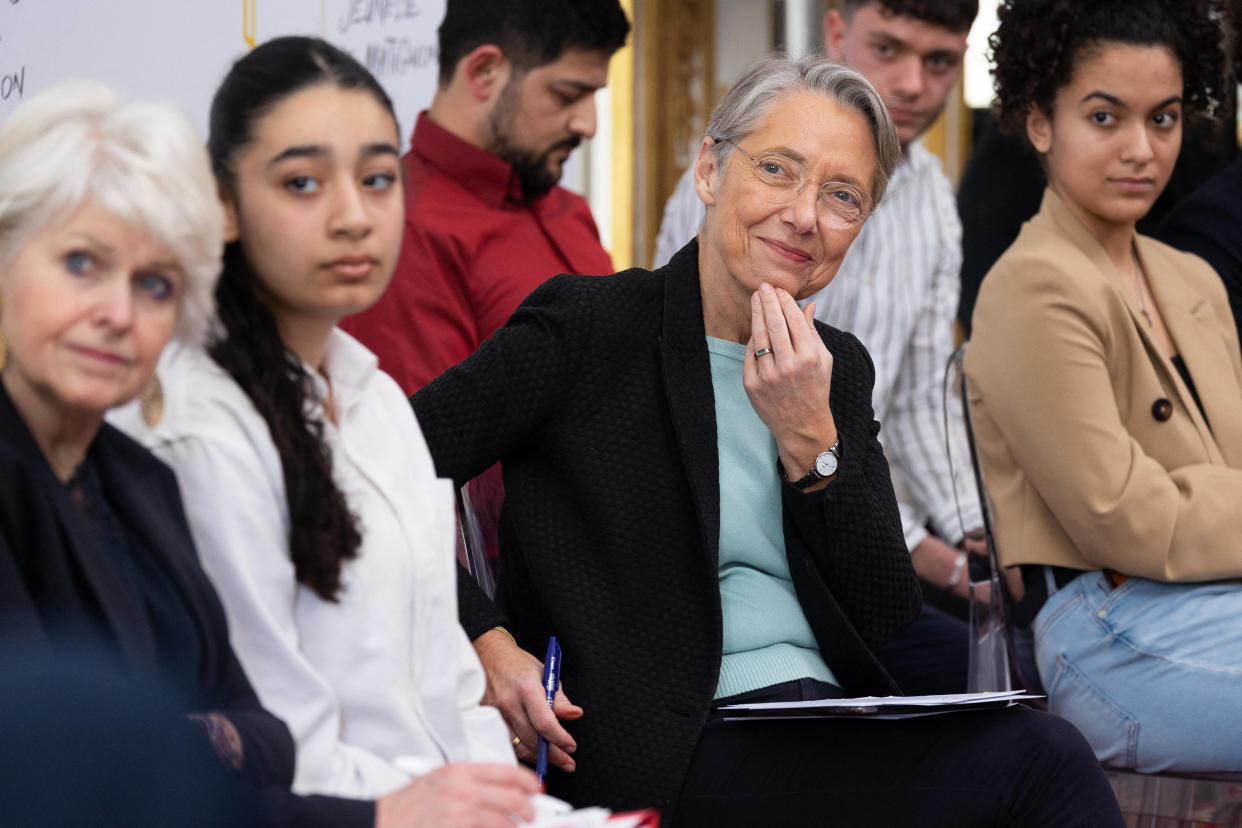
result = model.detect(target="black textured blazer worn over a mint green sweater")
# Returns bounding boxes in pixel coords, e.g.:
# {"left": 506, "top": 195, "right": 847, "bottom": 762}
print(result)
{"left": 411, "top": 242, "right": 922, "bottom": 816}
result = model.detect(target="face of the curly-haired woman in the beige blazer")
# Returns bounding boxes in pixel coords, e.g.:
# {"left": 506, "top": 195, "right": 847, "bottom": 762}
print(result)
{"left": 1027, "top": 43, "right": 1182, "bottom": 238}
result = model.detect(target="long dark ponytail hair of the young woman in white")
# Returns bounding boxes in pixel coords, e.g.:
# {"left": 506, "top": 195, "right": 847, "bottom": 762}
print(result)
{"left": 207, "top": 37, "right": 395, "bottom": 601}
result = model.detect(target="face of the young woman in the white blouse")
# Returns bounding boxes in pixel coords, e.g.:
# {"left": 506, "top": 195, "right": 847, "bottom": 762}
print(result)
{"left": 226, "top": 83, "right": 405, "bottom": 351}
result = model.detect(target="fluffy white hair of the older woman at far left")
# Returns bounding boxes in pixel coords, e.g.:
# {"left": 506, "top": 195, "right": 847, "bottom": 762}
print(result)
{"left": 0, "top": 79, "right": 224, "bottom": 344}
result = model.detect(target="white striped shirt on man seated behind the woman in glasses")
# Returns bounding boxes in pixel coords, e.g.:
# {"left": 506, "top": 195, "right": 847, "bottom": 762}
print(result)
{"left": 655, "top": 142, "right": 982, "bottom": 549}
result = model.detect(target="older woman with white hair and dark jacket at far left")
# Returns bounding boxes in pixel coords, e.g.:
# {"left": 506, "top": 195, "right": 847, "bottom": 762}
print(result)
{"left": 0, "top": 81, "right": 374, "bottom": 826}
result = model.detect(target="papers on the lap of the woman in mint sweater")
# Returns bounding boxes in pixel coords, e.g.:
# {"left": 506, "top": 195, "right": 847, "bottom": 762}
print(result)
{"left": 720, "top": 690, "right": 1043, "bottom": 721}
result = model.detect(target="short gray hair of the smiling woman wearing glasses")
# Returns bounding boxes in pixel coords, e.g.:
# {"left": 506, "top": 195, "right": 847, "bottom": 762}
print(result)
{"left": 707, "top": 52, "right": 902, "bottom": 207}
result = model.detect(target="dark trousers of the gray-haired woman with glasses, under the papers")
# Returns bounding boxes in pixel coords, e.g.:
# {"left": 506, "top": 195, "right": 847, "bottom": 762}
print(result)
{"left": 672, "top": 680, "right": 1124, "bottom": 828}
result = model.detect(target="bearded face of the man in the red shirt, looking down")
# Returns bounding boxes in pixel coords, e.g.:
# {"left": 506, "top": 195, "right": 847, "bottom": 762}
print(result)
{"left": 487, "top": 48, "right": 611, "bottom": 195}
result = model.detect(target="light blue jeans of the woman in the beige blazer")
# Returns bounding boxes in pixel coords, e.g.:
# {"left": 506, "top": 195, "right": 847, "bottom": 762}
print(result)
{"left": 1035, "top": 572, "right": 1242, "bottom": 773}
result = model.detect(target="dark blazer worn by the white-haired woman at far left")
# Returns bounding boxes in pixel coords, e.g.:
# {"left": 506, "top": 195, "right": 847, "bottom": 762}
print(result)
{"left": 0, "top": 386, "right": 374, "bottom": 826}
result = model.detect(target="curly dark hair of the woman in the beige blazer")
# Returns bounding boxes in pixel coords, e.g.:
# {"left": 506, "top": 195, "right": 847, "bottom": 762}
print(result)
{"left": 987, "top": 0, "right": 1226, "bottom": 135}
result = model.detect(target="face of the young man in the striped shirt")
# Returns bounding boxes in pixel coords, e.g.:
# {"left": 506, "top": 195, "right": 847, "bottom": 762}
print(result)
{"left": 823, "top": 4, "right": 969, "bottom": 146}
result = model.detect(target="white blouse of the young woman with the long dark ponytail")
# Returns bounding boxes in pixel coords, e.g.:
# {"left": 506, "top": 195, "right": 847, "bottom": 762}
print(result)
{"left": 112, "top": 330, "right": 514, "bottom": 798}
